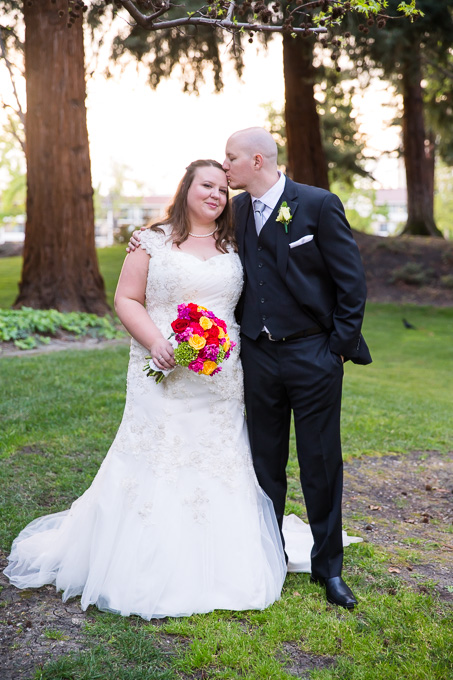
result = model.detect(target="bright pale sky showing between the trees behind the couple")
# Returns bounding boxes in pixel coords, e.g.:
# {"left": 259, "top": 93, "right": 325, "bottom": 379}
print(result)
{"left": 0, "top": 36, "right": 402, "bottom": 196}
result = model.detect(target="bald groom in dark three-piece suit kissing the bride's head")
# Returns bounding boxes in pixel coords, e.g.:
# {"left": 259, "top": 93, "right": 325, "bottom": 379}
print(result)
{"left": 223, "top": 128, "right": 371, "bottom": 609}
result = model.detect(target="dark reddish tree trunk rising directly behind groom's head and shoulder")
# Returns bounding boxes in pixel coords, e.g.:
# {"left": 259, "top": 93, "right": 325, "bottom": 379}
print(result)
{"left": 283, "top": 35, "right": 329, "bottom": 189}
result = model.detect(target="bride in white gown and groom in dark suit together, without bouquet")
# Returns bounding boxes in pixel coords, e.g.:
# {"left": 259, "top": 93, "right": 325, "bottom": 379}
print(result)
{"left": 5, "top": 128, "right": 371, "bottom": 618}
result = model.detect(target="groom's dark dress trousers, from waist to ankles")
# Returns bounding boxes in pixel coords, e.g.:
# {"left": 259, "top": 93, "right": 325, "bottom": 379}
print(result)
{"left": 241, "top": 333, "right": 343, "bottom": 578}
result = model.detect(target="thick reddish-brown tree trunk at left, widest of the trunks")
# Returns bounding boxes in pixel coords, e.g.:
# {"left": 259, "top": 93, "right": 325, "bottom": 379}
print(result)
{"left": 14, "top": 0, "right": 110, "bottom": 315}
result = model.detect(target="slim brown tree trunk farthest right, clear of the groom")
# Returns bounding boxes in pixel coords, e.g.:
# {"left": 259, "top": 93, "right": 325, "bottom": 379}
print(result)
{"left": 402, "top": 53, "right": 442, "bottom": 237}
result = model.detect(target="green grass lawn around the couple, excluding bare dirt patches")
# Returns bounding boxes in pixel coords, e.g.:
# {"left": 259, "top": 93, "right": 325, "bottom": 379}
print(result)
{"left": 0, "top": 246, "right": 453, "bottom": 680}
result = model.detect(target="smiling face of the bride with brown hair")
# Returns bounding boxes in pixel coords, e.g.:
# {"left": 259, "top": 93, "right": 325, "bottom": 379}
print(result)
{"left": 187, "top": 165, "right": 228, "bottom": 225}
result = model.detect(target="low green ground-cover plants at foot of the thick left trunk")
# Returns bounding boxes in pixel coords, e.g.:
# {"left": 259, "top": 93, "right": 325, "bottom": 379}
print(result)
{"left": 0, "top": 307, "right": 122, "bottom": 349}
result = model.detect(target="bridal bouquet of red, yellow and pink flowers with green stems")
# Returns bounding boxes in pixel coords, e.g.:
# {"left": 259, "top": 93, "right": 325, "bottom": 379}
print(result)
{"left": 143, "top": 302, "right": 236, "bottom": 383}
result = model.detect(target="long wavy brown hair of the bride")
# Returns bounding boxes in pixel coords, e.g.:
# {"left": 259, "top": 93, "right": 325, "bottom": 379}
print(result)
{"left": 151, "top": 159, "right": 236, "bottom": 253}
